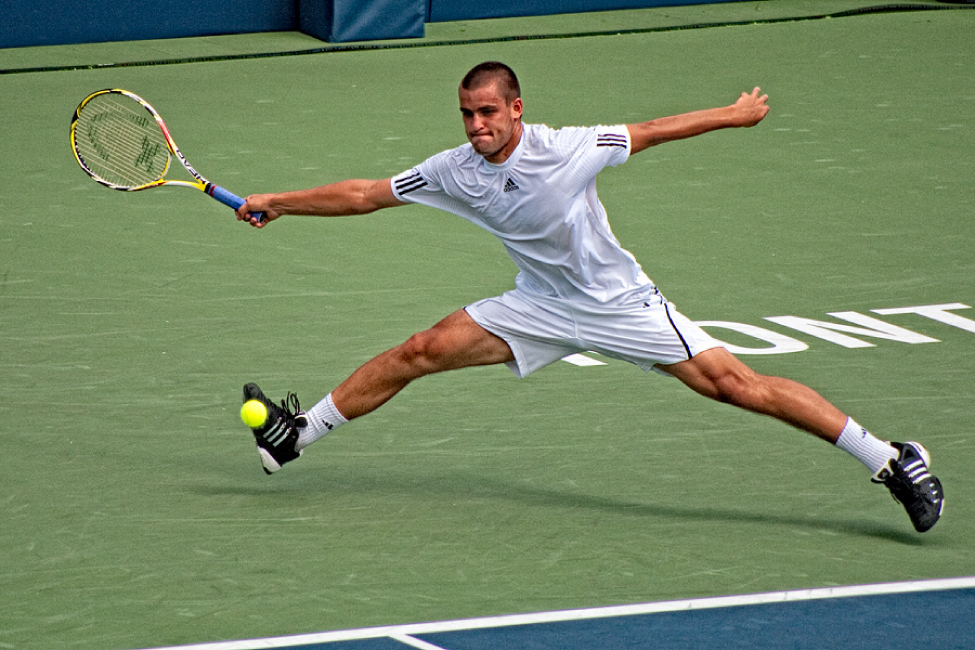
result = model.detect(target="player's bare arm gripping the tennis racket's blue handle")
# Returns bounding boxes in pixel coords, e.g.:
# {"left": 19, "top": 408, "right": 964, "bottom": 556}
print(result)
{"left": 237, "top": 178, "right": 404, "bottom": 228}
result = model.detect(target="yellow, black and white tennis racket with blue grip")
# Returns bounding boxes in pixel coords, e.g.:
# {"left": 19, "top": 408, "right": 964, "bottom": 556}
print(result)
{"left": 71, "top": 88, "right": 264, "bottom": 220}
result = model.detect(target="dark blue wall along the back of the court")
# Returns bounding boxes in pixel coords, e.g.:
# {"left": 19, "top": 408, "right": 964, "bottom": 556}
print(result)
{"left": 0, "top": 0, "right": 728, "bottom": 47}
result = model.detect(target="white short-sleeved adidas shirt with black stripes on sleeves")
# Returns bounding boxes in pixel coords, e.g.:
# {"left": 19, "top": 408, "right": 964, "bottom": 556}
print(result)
{"left": 392, "top": 124, "right": 656, "bottom": 304}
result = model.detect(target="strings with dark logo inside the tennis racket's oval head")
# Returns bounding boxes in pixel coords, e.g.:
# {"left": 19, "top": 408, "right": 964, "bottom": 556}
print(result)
{"left": 74, "top": 94, "right": 170, "bottom": 189}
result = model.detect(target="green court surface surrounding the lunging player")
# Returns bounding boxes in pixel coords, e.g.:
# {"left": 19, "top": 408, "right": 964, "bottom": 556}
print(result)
{"left": 0, "top": 2, "right": 975, "bottom": 650}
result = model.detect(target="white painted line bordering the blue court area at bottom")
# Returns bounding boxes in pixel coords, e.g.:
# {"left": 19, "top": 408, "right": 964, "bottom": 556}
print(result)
{"left": 141, "top": 577, "right": 975, "bottom": 650}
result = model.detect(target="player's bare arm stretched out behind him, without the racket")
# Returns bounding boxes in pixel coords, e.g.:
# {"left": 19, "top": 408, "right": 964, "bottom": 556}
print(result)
{"left": 626, "top": 88, "right": 769, "bottom": 155}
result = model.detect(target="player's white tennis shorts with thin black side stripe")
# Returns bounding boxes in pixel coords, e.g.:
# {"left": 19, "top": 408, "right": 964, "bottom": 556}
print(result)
{"left": 465, "top": 290, "right": 723, "bottom": 377}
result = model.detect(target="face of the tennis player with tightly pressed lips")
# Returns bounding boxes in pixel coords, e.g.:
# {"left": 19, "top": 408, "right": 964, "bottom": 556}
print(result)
{"left": 459, "top": 82, "right": 522, "bottom": 164}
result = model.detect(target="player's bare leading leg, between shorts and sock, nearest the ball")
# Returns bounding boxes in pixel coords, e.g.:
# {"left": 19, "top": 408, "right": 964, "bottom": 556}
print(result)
{"left": 332, "top": 309, "right": 514, "bottom": 420}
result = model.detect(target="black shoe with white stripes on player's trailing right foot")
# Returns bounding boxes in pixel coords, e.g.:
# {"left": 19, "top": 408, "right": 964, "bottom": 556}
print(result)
{"left": 872, "top": 442, "right": 945, "bottom": 533}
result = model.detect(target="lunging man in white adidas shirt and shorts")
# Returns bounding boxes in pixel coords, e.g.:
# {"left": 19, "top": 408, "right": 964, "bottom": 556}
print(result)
{"left": 237, "top": 62, "right": 944, "bottom": 532}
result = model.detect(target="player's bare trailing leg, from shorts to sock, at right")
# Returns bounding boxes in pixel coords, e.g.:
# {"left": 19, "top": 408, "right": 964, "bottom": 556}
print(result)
{"left": 660, "top": 348, "right": 847, "bottom": 443}
